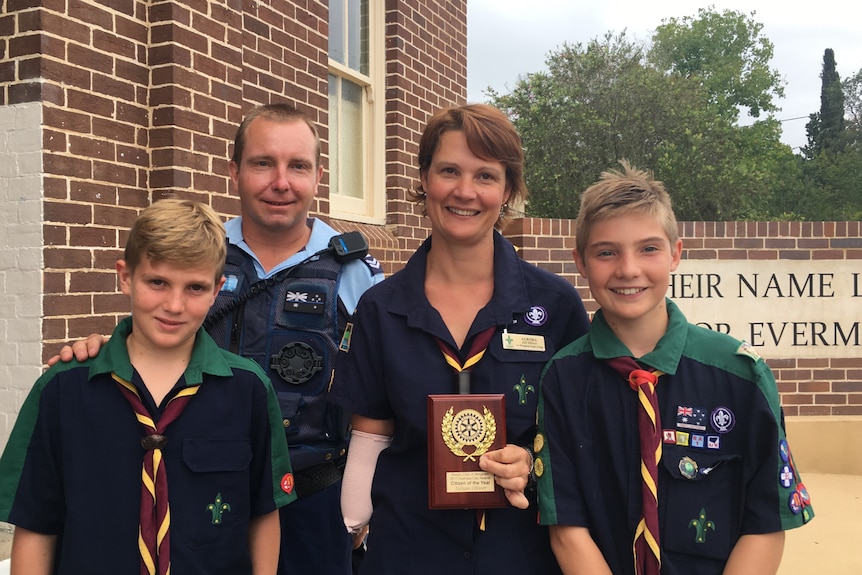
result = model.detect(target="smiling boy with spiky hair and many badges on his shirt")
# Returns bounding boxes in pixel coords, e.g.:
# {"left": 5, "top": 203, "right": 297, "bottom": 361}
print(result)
{"left": 535, "top": 161, "right": 814, "bottom": 575}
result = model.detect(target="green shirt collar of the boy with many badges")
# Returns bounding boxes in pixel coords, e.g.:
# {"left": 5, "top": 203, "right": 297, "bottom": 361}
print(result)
{"left": 590, "top": 298, "right": 689, "bottom": 375}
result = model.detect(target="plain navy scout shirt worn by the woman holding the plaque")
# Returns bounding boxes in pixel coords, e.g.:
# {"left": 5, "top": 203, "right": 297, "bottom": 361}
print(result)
{"left": 330, "top": 233, "right": 588, "bottom": 575}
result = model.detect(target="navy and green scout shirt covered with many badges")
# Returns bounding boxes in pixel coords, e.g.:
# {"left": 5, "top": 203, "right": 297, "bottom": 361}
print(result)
{"left": 536, "top": 300, "right": 814, "bottom": 575}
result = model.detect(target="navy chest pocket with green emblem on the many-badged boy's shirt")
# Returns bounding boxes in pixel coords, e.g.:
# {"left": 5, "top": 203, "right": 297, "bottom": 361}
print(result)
{"left": 659, "top": 445, "right": 743, "bottom": 563}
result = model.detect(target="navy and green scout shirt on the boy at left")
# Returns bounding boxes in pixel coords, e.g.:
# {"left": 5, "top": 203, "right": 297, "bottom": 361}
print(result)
{"left": 0, "top": 318, "right": 295, "bottom": 575}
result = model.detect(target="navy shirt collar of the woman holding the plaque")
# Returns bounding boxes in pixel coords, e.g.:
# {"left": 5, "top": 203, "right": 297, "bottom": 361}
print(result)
{"left": 388, "top": 230, "right": 530, "bottom": 341}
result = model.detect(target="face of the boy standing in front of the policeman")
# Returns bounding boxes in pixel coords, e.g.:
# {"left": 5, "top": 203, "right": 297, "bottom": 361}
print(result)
{"left": 117, "top": 256, "right": 224, "bottom": 354}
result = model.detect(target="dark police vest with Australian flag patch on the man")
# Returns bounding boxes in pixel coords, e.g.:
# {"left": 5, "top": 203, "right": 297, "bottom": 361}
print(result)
{"left": 204, "top": 244, "right": 349, "bottom": 471}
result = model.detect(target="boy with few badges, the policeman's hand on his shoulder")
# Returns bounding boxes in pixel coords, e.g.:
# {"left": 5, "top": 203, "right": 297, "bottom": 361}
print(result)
{"left": 0, "top": 199, "right": 295, "bottom": 575}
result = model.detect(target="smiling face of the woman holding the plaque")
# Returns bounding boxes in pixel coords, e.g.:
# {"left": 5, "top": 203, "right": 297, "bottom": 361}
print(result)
{"left": 421, "top": 131, "right": 509, "bottom": 248}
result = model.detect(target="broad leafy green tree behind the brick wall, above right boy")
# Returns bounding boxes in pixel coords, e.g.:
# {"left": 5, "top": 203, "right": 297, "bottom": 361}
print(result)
{"left": 489, "top": 10, "right": 792, "bottom": 220}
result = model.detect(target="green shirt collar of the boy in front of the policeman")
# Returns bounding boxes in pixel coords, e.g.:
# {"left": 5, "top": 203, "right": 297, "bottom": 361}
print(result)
{"left": 88, "top": 316, "right": 233, "bottom": 386}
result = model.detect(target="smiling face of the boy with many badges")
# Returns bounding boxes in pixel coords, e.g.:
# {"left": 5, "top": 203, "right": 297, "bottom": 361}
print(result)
{"left": 574, "top": 212, "right": 682, "bottom": 337}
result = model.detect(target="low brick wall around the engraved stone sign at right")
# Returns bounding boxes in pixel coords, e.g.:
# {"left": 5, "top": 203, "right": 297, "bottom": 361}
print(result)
{"left": 506, "top": 218, "right": 862, "bottom": 416}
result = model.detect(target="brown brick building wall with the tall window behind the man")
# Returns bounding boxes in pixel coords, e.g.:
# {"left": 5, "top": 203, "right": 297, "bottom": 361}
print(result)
{"left": 0, "top": 0, "right": 466, "bottom": 360}
